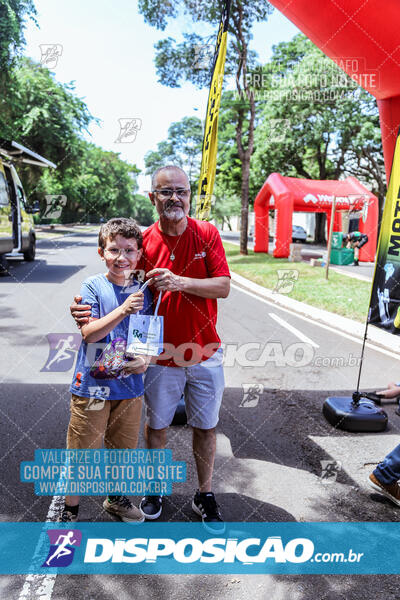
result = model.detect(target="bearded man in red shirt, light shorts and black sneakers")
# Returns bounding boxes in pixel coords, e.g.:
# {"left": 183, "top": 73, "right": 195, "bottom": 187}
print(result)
{"left": 71, "top": 165, "right": 230, "bottom": 531}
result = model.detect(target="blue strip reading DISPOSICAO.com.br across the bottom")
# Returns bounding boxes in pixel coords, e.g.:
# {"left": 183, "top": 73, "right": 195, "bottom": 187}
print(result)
{"left": 0, "top": 522, "right": 400, "bottom": 574}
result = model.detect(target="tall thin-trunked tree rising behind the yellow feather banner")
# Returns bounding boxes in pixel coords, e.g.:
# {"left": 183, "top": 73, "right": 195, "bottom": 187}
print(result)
{"left": 139, "top": 0, "right": 272, "bottom": 254}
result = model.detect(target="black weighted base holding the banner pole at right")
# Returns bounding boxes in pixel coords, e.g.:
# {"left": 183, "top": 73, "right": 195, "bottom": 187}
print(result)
{"left": 322, "top": 396, "right": 388, "bottom": 432}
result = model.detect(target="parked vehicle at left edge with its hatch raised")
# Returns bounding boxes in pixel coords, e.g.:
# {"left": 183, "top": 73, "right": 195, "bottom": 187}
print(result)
{"left": 0, "top": 141, "right": 56, "bottom": 272}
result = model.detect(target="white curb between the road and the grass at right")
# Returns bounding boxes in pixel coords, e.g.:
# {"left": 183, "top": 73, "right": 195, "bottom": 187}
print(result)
{"left": 231, "top": 270, "right": 400, "bottom": 356}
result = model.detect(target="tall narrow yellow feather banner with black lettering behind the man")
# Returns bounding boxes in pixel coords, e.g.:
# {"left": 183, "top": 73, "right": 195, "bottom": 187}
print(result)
{"left": 196, "top": 2, "right": 230, "bottom": 221}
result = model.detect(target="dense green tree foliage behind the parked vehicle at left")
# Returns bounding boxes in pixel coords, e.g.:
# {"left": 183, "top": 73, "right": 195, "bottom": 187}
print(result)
{"left": 0, "top": 58, "right": 144, "bottom": 222}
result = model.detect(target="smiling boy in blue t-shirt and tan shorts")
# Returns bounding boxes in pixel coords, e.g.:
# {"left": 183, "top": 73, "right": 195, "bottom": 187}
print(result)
{"left": 59, "top": 218, "right": 153, "bottom": 522}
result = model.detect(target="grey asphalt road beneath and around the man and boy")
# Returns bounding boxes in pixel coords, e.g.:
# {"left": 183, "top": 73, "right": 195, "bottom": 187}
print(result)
{"left": 0, "top": 234, "right": 400, "bottom": 600}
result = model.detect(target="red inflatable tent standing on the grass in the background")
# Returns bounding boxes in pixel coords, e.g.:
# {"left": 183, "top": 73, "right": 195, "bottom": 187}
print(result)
{"left": 254, "top": 173, "right": 379, "bottom": 262}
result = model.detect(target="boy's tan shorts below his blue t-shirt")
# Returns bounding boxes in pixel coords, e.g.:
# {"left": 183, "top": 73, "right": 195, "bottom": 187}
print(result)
{"left": 67, "top": 394, "right": 143, "bottom": 449}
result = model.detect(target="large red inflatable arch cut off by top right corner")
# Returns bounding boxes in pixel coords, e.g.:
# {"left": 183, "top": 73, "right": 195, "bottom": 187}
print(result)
{"left": 270, "top": 0, "right": 400, "bottom": 183}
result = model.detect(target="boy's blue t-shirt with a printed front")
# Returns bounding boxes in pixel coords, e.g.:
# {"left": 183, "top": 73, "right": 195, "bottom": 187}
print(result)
{"left": 70, "top": 273, "right": 153, "bottom": 400}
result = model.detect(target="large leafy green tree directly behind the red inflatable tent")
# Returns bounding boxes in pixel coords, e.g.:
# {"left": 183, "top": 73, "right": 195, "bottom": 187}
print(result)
{"left": 252, "top": 35, "right": 385, "bottom": 242}
